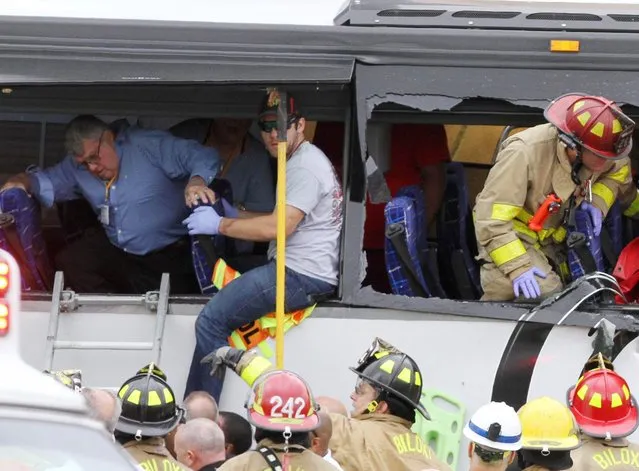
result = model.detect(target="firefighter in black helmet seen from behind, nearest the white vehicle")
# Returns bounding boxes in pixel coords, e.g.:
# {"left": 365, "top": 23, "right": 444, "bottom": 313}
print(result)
{"left": 114, "top": 364, "right": 189, "bottom": 471}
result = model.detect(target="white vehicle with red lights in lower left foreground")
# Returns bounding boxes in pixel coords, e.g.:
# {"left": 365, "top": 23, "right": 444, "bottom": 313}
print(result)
{"left": 0, "top": 250, "right": 136, "bottom": 471}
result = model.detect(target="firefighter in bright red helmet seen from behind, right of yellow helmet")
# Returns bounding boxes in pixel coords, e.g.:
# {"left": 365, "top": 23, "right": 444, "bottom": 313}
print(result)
{"left": 568, "top": 361, "right": 639, "bottom": 471}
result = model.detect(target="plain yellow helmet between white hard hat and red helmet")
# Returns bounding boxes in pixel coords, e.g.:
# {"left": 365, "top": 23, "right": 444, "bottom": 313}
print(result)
{"left": 517, "top": 396, "right": 581, "bottom": 453}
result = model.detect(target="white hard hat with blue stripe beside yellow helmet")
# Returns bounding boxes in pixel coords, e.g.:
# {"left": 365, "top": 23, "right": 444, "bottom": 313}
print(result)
{"left": 464, "top": 402, "right": 521, "bottom": 451}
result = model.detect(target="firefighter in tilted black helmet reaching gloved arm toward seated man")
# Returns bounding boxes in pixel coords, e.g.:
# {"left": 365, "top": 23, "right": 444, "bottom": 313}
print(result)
{"left": 203, "top": 339, "right": 450, "bottom": 471}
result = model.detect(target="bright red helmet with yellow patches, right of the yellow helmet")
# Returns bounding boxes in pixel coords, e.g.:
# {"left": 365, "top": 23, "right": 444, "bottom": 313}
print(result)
{"left": 568, "top": 369, "right": 638, "bottom": 439}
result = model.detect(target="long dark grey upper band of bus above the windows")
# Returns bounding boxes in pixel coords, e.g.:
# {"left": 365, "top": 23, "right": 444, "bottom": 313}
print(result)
{"left": 0, "top": 16, "right": 639, "bottom": 88}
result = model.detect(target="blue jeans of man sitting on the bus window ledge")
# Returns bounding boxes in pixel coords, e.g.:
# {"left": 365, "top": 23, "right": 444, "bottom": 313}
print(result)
{"left": 184, "top": 260, "right": 335, "bottom": 403}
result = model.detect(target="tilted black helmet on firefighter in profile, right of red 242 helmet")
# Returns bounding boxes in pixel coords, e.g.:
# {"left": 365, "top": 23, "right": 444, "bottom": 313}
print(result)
{"left": 351, "top": 346, "right": 430, "bottom": 420}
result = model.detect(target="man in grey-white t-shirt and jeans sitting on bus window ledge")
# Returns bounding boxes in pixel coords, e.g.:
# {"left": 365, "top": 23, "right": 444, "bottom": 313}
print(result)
{"left": 184, "top": 92, "right": 343, "bottom": 402}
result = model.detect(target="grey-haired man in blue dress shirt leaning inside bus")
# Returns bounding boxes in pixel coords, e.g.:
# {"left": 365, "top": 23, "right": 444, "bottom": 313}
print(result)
{"left": 3, "top": 115, "right": 220, "bottom": 294}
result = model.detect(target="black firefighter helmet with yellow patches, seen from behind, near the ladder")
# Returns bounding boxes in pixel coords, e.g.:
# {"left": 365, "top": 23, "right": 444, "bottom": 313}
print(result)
{"left": 115, "top": 368, "right": 183, "bottom": 437}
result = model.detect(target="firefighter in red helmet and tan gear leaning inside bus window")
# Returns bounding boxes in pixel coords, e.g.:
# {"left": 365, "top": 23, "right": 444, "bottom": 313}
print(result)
{"left": 474, "top": 93, "right": 639, "bottom": 301}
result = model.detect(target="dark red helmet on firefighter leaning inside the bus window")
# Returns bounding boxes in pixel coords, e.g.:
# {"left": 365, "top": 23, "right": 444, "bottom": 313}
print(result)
{"left": 544, "top": 93, "right": 635, "bottom": 160}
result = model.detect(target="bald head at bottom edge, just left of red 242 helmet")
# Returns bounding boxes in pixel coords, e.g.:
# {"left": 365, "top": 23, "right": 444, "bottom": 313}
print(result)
{"left": 175, "top": 418, "right": 226, "bottom": 469}
